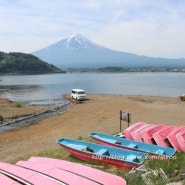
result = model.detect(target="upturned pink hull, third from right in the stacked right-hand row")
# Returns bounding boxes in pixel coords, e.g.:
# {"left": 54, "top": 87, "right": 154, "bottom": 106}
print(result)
{"left": 153, "top": 126, "right": 176, "bottom": 147}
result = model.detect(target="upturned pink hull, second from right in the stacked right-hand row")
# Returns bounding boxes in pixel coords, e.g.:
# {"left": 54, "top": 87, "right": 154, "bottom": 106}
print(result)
{"left": 167, "top": 126, "right": 185, "bottom": 152}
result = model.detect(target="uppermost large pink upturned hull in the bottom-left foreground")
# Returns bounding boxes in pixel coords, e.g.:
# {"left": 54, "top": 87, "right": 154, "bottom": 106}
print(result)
{"left": 16, "top": 157, "right": 126, "bottom": 185}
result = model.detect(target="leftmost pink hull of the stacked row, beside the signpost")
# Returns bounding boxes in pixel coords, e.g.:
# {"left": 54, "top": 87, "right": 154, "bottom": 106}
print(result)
{"left": 124, "top": 122, "right": 148, "bottom": 140}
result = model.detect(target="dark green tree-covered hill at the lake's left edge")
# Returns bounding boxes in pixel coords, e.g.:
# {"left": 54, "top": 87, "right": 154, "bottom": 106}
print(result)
{"left": 0, "top": 52, "right": 62, "bottom": 74}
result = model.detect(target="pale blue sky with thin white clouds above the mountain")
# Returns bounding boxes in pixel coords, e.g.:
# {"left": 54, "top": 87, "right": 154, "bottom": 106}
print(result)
{"left": 0, "top": 0, "right": 185, "bottom": 58}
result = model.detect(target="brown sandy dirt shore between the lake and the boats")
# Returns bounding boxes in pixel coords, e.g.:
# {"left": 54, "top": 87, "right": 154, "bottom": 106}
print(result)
{"left": 0, "top": 95, "right": 185, "bottom": 163}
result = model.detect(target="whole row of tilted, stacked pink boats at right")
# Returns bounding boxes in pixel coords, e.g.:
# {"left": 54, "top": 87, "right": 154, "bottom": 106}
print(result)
{"left": 124, "top": 122, "right": 185, "bottom": 152}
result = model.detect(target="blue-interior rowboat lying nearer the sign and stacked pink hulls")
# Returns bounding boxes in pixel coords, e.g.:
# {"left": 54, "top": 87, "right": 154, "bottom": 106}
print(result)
{"left": 89, "top": 132, "right": 176, "bottom": 158}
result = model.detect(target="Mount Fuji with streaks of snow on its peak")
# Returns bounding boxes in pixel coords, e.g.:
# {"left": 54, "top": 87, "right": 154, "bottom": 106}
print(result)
{"left": 32, "top": 34, "right": 185, "bottom": 68}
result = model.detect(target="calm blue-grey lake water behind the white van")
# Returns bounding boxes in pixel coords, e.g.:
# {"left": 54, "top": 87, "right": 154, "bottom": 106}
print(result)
{"left": 0, "top": 73, "right": 185, "bottom": 102}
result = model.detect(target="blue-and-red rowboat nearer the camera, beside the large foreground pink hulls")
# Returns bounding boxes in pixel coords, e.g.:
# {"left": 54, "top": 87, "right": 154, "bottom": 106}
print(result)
{"left": 56, "top": 138, "right": 148, "bottom": 170}
